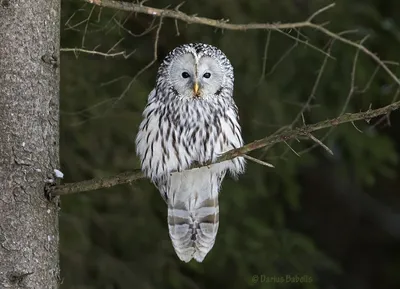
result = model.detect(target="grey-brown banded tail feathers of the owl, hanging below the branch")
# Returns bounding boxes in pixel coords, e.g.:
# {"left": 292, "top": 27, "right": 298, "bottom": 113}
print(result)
{"left": 168, "top": 196, "right": 219, "bottom": 262}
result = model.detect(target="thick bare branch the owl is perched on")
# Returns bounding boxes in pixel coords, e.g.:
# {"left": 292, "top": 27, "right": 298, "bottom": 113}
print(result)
{"left": 49, "top": 101, "right": 400, "bottom": 196}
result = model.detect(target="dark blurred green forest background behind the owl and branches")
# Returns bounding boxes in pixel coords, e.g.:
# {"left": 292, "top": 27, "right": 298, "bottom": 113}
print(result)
{"left": 60, "top": 0, "right": 400, "bottom": 289}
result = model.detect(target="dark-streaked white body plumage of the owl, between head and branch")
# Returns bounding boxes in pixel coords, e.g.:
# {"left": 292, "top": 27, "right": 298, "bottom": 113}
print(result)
{"left": 136, "top": 90, "right": 245, "bottom": 181}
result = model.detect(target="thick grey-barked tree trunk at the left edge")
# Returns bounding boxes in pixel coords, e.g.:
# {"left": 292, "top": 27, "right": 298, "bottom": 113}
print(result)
{"left": 0, "top": 0, "right": 60, "bottom": 289}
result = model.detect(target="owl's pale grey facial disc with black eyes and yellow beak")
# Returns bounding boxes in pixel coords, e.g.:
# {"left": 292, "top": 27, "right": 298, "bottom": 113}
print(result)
{"left": 170, "top": 53, "right": 224, "bottom": 98}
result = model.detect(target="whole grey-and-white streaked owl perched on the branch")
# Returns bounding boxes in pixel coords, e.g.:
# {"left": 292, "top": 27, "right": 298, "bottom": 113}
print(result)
{"left": 136, "top": 43, "right": 245, "bottom": 262}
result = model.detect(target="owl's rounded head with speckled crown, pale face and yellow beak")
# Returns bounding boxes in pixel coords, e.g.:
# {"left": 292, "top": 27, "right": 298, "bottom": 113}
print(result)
{"left": 157, "top": 43, "right": 234, "bottom": 99}
